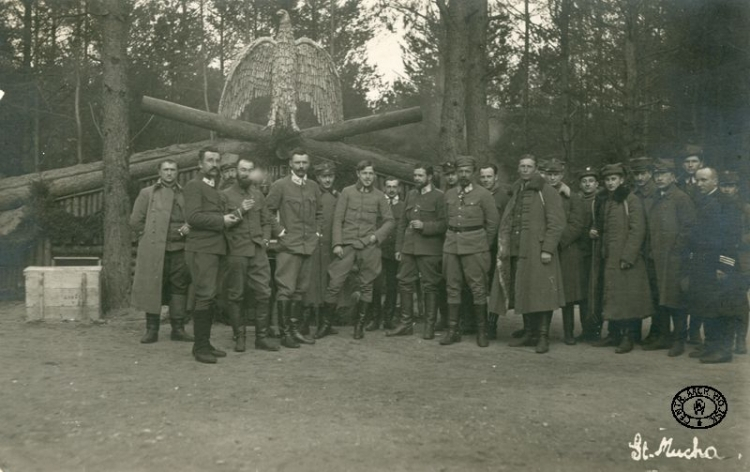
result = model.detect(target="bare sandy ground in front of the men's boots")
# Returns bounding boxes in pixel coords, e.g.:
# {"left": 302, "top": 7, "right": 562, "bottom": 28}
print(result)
{"left": 0, "top": 302, "right": 750, "bottom": 472}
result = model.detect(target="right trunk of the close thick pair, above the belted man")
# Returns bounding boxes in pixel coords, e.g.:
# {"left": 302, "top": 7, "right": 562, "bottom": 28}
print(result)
{"left": 466, "top": 0, "right": 490, "bottom": 162}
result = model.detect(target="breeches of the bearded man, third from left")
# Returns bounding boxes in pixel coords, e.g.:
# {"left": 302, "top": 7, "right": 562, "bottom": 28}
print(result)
{"left": 224, "top": 253, "right": 271, "bottom": 303}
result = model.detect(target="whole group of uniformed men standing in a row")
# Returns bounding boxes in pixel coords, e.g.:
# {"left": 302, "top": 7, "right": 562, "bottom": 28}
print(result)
{"left": 130, "top": 148, "right": 750, "bottom": 363}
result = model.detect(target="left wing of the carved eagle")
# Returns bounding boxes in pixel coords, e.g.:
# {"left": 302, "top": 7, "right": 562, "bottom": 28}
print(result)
{"left": 219, "top": 37, "right": 276, "bottom": 119}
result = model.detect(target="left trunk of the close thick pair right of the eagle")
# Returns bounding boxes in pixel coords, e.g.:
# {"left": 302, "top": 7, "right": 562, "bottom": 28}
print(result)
{"left": 437, "top": 0, "right": 468, "bottom": 161}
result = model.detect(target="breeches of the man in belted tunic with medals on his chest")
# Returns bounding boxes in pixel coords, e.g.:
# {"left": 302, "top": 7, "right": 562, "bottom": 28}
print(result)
{"left": 443, "top": 251, "right": 490, "bottom": 305}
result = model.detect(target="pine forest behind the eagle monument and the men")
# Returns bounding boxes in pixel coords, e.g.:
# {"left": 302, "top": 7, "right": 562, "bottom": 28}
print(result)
{"left": 0, "top": 0, "right": 750, "bottom": 176}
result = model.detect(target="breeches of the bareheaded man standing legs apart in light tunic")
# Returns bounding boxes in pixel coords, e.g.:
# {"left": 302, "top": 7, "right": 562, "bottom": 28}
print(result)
{"left": 325, "top": 245, "right": 382, "bottom": 303}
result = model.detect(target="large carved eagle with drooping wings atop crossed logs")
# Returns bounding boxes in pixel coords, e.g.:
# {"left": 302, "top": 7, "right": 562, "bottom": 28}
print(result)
{"left": 219, "top": 10, "right": 344, "bottom": 131}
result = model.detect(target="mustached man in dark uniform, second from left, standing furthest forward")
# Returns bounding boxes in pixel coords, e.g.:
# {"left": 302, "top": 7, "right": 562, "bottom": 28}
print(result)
{"left": 184, "top": 148, "right": 239, "bottom": 364}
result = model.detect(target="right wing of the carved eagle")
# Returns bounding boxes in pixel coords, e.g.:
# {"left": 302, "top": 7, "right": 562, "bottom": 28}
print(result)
{"left": 295, "top": 38, "right": 344, "bottom": 125}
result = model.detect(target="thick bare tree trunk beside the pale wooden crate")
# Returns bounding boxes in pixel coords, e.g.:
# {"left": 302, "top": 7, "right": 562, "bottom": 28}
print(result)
{"left": 100, "top": 0, "right": 131, "bottom": 311}
